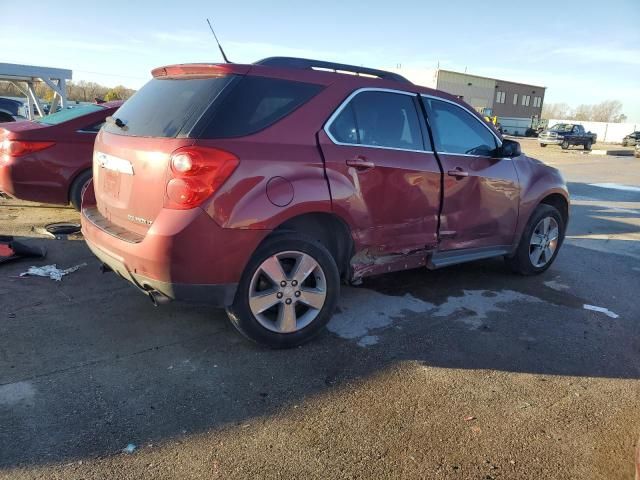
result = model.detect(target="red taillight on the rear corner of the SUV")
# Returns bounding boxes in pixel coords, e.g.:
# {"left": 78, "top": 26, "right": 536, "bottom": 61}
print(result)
{"left": 165, "top": 147, "right": 240, "bottom": 209}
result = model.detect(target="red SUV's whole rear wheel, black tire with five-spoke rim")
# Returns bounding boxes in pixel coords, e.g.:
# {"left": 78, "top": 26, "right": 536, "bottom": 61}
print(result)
{"left": 227, "top": 233, "right": 340, "bottom": 348}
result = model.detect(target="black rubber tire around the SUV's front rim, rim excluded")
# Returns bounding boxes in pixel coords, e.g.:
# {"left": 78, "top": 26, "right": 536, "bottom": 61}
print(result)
{"left": 505, "top": 204, "right": 565, "bottom": 275}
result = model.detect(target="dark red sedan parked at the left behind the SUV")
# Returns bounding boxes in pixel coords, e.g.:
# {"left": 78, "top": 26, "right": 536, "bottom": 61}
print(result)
{"left": 0, "top": 101, "right": 122, "bottom": 210}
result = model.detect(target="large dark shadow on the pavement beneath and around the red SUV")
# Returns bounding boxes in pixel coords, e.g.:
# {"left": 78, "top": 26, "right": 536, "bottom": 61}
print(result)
{"left": 0, "top": 186, "right": 640, "bottom": 468}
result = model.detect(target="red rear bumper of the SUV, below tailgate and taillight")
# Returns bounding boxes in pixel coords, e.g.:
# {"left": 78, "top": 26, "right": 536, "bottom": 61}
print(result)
{"left": 81, "top": 199, "right": 269, "bottom": 306}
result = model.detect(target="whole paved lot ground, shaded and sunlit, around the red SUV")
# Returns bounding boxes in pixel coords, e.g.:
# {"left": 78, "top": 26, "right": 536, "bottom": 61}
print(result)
{"left": 0, "top": 140, "right": 640, "bottom": 479}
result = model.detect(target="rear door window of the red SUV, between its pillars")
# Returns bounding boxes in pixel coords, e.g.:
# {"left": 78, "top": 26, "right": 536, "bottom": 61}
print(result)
{"left": 329, "top": 91, "right": 430, "bottom": 150}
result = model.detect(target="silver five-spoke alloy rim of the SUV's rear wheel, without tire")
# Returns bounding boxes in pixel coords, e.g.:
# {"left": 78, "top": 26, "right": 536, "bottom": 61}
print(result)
{"left": 249, "top": 251, "right": 327, "bottom": 333}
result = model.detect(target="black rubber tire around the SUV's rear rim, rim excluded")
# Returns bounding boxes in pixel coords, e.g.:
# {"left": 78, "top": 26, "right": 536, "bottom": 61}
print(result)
{"left": 227, "top": 232, "right": 340, "bottom": 348}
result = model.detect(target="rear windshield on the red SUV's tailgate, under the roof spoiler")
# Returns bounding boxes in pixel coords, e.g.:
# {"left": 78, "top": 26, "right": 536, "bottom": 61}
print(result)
{"left": 104, "top": 75, "right": 234, "bottom": 137}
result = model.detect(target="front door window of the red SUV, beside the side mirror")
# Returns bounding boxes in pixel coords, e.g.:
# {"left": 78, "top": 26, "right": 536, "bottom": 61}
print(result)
{"left": 423, "top": 98, "right": 498, "bottom": 156}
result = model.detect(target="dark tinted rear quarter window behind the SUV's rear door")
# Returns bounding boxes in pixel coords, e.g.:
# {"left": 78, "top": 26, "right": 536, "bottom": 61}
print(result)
{"left": 198, "top": 76, "right": 322, "bottom": 138}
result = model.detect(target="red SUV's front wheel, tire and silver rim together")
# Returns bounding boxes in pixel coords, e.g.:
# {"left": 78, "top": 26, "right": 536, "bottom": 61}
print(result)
{"left": 506, "top": 204, "right": 565, "bottom": 275}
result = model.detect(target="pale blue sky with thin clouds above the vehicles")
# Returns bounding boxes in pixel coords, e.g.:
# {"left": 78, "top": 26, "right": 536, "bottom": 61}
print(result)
{"left": 0, "top": 0, "right": 640, "bottom": 122}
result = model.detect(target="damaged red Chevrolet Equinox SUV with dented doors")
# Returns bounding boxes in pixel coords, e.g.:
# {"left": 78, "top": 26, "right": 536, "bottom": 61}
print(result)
{"left": 82, "top": 57, "right": 569, "bottom": 347}
